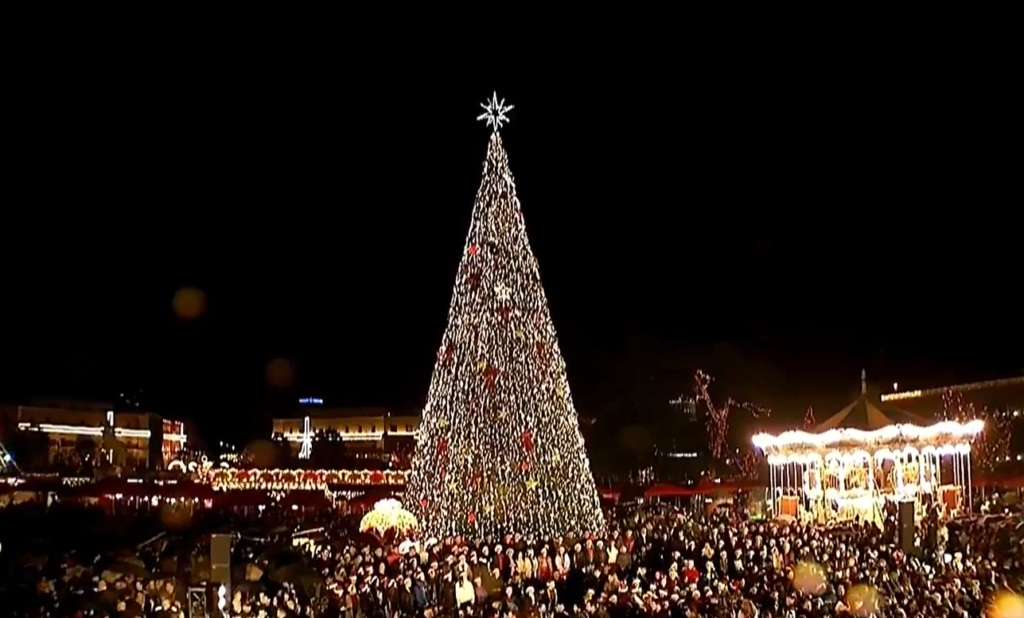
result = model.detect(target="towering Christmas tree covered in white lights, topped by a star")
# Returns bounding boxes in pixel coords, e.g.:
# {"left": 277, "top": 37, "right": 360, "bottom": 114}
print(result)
{"left": 406, "top": 96, "right": 604, "bottom": 537}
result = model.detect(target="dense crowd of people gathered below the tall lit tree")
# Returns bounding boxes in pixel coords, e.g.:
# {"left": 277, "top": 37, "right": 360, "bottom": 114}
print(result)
{"left": 0, "top": 497, "right": 1024, "bottom": 618}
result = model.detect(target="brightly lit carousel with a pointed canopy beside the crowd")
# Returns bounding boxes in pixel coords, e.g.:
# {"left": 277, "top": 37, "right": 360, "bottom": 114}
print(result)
{"left": 754, "top": 372, "right": 984, "bottom": 523}
